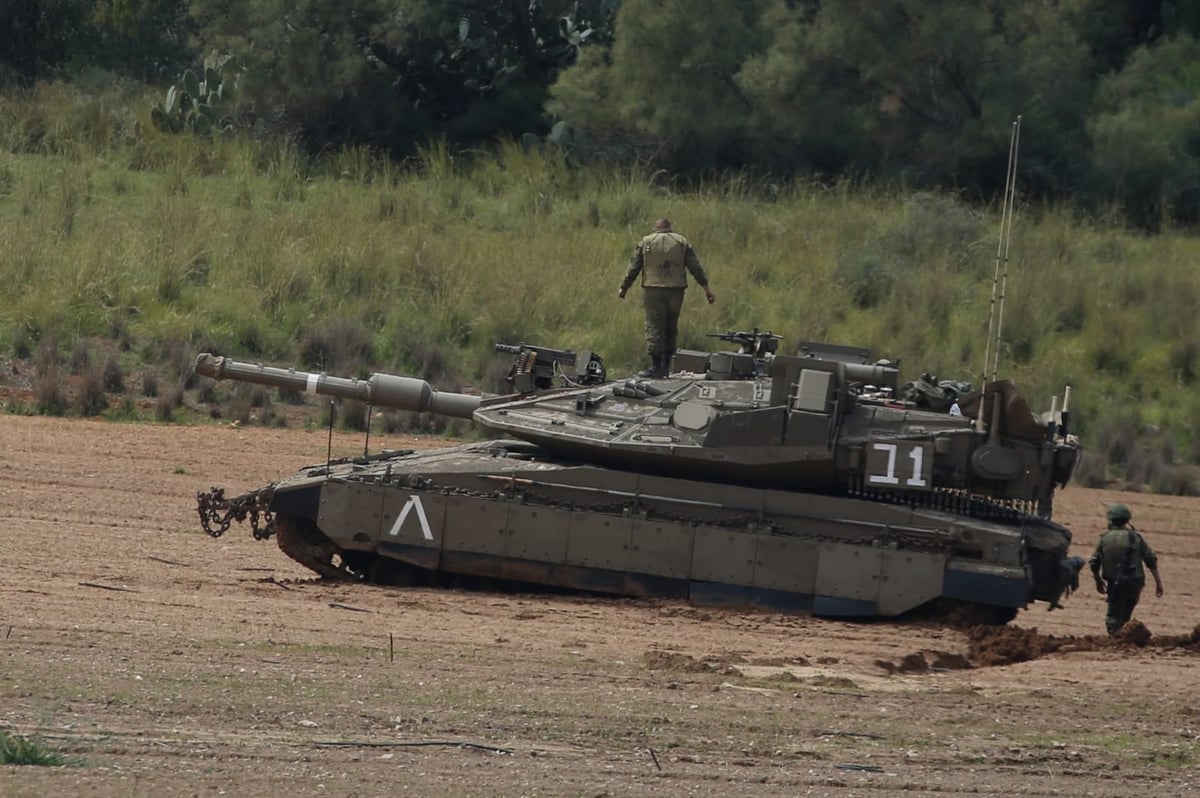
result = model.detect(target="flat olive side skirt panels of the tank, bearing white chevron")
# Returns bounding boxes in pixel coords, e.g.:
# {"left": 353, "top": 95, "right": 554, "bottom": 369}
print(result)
{"left": 302, "top": 479, "right": 1028, "bottom": 617}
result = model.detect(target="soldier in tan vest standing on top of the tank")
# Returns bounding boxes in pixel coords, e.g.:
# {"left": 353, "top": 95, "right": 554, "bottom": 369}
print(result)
{"left": 617, "top": 218, "right": 716, "bottom": 377}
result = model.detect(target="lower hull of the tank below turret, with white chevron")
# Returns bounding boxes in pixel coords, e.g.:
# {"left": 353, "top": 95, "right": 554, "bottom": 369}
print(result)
{"left": 243, "top": 442, "right": 1070, "bottom": 622}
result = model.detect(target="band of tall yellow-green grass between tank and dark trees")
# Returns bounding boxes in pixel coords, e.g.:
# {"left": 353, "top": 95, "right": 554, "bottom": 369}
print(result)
{"left": 0, "top": 86, "right": 1200, "bottom": 491}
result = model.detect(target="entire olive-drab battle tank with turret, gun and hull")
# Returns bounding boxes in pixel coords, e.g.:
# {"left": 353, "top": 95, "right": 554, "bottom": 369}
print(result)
{"left": 194, "top": 330, "right": 1079, "bottom": 623}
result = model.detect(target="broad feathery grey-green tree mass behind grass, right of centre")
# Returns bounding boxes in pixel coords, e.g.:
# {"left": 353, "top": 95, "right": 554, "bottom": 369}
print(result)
{"left": 550, "top": 0, "right": 1099, "bottom": 194}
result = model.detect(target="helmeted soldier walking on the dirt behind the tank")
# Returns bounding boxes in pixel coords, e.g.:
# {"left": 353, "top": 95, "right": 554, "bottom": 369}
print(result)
{"left": 1087, "top": 504, "right": 1163, "bottom": 635}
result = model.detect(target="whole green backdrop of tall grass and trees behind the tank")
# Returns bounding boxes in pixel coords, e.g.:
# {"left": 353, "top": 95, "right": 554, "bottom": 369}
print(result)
{"left": 0, "top": 0, "right": 1200, "bottom": 492}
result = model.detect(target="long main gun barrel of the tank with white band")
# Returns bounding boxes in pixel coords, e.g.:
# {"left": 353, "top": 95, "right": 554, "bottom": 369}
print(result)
{"left": 193, "top": 352, "right": 481, "bottom": 419}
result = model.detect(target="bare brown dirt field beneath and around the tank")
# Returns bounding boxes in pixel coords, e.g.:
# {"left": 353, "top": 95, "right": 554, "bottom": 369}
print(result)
{"left": 0, "top": 415, "right": 1200, "bottom": 798}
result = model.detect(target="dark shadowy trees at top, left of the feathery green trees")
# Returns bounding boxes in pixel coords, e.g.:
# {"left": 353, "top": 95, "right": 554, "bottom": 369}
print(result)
{"left": 190, "top": 0, "right": 613, "bottom": 152}
